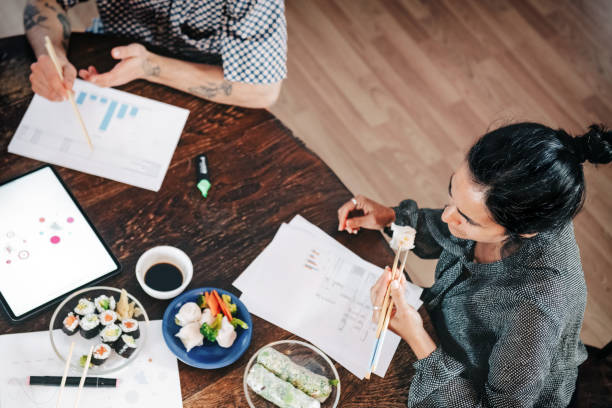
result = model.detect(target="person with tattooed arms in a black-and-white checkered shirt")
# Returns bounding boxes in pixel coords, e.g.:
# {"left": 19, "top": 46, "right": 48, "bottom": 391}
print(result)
{"left": 24, "top": 0, "right": 287, "bottom": 108}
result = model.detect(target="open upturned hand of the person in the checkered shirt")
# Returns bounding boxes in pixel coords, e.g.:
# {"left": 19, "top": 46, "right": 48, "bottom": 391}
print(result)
{"left": 79, "top": 43, "right": 160, "bottom": 87}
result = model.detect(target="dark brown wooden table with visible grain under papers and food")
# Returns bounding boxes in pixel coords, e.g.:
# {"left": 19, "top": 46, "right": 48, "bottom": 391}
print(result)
{"left": 0, "top": 34, "right": 430, "bottom": 407}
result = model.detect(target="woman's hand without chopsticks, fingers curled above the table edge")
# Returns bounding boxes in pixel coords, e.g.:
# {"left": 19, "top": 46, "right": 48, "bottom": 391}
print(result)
{"left": 338, "top": 195, "right": 395, "bottom": 234}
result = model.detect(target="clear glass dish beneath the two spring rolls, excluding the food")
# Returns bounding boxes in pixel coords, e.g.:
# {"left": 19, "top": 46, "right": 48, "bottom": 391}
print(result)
{"left": 242, "top": 340, "right": 340, "bottom": 408}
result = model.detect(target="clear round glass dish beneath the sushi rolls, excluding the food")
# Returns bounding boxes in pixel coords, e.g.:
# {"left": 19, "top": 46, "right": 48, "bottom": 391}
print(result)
{"left": 49, "top": 286, "right": 149, "bottom": 375}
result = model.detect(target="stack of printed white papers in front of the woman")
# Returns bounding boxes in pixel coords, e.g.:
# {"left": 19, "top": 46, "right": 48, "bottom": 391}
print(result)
{"left": 234, "top": 215, "right": 423, "bottom": 379}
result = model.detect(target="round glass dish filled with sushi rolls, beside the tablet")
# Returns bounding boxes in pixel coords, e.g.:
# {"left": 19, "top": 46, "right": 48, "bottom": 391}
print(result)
{"left": 49, "top": 286, "right": 149, "bottom": 375}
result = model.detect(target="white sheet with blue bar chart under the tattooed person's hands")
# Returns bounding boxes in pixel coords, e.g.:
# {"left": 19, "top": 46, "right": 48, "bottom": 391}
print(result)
{"left": 8, "top": 79, "right": 189, "bottom": 191}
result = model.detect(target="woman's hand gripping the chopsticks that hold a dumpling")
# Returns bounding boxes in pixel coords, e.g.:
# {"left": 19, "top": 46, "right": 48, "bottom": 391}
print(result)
{"left": 370, "top": 267, "right": 436, "bottom": 359}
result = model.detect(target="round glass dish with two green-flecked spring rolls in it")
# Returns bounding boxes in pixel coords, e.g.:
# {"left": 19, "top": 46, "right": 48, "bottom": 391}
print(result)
{"left": 243, "top": 340, "right": 340, "bottom": 408}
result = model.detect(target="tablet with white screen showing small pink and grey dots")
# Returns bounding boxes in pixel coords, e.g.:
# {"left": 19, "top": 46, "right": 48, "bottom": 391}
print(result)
{"left": 0, "top": 165, "right": 121, "bottom": 321}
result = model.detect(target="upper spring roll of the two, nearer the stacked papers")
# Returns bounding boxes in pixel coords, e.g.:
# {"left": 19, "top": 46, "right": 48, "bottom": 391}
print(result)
{"left": 257, "top": 347, "right": 332, "bottom": 402}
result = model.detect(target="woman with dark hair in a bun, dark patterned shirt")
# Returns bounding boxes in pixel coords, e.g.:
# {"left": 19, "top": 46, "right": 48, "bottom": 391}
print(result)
{"left": 338, "top": 123, "right": 612, "bottom": 407}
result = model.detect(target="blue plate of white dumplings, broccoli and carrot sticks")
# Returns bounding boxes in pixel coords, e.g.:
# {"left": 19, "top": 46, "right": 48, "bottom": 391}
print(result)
{"left": 162, "top": 287, "right": 253, "bottom": 369}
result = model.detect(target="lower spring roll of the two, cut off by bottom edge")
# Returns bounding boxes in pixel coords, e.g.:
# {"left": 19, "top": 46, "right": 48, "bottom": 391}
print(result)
{"left": 247, "top": 363, "right": 321, "bottom": 408}
